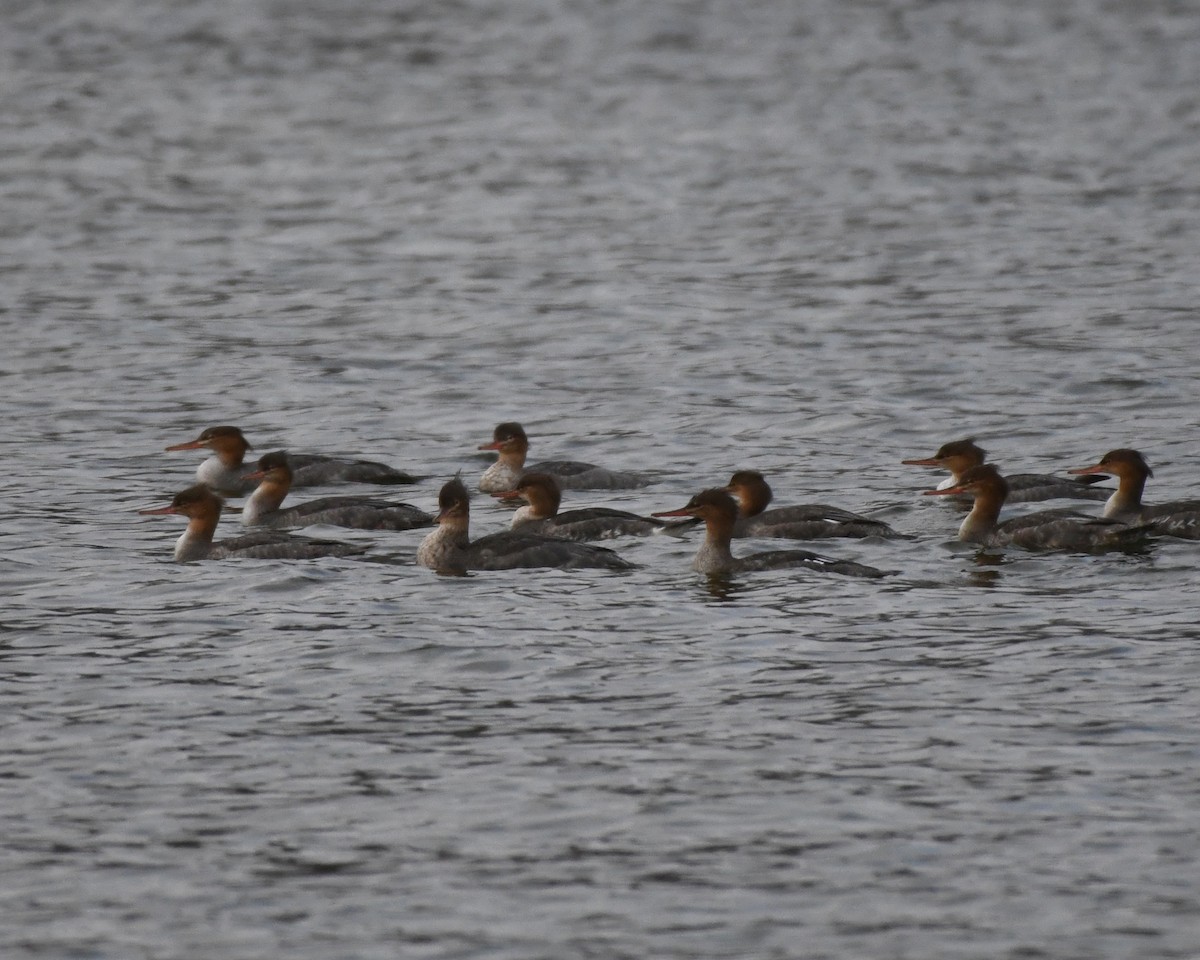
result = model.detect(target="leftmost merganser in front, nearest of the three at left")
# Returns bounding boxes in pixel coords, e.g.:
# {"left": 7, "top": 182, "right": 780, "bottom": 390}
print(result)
{"left": 139, "top": 484, "right": 366, "bottom": 563}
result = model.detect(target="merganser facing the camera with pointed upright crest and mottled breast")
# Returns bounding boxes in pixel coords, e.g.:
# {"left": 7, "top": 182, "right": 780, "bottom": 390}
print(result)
{"left": 416, "top": 476, "right": 636, "bottom": 576}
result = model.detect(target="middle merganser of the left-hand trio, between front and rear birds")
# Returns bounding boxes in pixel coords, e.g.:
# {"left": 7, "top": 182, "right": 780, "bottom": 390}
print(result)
{"left": 241, "top": 450, "right": 433, "bottom": 530}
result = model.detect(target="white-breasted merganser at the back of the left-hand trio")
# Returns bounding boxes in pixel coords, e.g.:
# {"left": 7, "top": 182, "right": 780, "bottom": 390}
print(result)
{"left": 167, "top": 426, "right": 419, "bottom": 497}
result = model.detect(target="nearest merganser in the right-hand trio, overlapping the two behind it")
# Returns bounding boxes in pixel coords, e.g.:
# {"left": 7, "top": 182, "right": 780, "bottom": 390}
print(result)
{"left": 925, "top": 463, "right": 1150, "bottom": 551}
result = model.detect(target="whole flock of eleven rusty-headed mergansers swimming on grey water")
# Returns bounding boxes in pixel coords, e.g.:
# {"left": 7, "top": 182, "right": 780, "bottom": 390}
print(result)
{"left": 142, "top": 422, "right": 1200, "bottom": 577}
